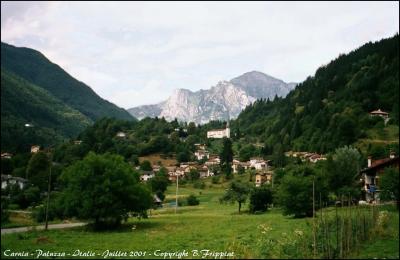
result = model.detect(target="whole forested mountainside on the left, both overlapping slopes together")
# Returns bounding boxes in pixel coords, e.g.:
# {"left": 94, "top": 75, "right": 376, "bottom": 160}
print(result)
{"left": 1, "top": 43, "right": 134, "bottom": 152}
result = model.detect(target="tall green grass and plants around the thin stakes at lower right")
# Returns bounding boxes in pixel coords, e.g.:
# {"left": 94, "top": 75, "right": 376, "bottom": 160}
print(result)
{"left": 259, "top": 197, "right": 390, "bottom": 259}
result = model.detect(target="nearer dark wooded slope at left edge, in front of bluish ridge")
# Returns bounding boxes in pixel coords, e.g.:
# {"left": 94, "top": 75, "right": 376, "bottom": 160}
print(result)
{"left": 1, "top": 69, "right": 91, "bottom": 152}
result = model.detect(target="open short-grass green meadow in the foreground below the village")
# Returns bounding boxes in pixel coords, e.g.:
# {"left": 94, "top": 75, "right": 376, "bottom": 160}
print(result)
{"left": 1, "top": 177, "right": 398, "bottom": 258}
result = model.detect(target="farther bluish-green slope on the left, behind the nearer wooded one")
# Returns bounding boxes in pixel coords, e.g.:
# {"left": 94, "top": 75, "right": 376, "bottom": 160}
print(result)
{"left": 1, "top": 42, "right": 133, "bottom": 121}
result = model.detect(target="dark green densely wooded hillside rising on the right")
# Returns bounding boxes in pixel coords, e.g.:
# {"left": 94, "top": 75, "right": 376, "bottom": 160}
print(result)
{"left": 232, "top": 34, "right": 399, "bottom": 152}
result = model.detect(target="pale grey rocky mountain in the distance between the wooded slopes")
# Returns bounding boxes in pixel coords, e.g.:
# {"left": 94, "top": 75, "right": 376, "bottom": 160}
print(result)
{"left": 128, "top": 71, "right": 296, "bottom": 124}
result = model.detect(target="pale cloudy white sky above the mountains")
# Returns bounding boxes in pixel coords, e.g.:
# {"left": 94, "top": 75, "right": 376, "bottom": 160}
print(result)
{"left": 1, "top": 1, "right": 399, "bottom": 108}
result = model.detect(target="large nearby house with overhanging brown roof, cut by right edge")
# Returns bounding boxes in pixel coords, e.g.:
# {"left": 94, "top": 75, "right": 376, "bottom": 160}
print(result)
{"left": 360, "top": 152, "right": 399, "bottom": 203}
